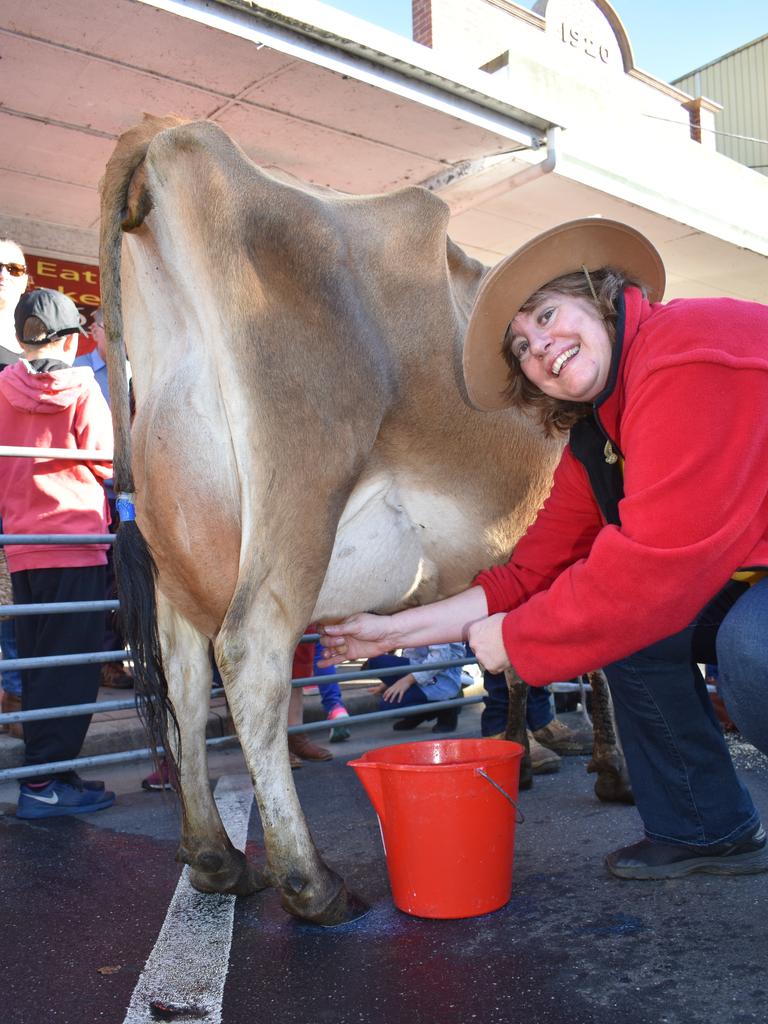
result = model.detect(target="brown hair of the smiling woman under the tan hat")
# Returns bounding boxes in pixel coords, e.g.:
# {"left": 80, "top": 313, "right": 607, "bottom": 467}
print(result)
{"left": 502, "top": 267, "right": 646, "bottom": 435}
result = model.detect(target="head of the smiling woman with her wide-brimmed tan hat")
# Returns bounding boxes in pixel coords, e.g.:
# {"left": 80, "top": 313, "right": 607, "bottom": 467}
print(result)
{"left": 464, "top": 217, "right": 666, "bottom": 419}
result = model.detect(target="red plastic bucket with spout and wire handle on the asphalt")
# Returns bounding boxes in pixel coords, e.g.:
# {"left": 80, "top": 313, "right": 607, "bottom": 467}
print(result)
{"left": 348, "top": 739, "right": 523, "bottom": 918}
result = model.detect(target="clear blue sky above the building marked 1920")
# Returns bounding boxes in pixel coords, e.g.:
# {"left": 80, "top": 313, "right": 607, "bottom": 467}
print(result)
{"left": 325, "top": 0, "right": 768, "bottom": 82}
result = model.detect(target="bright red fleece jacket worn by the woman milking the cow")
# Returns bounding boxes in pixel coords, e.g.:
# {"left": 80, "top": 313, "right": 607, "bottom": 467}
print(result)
{"left": 476, "top": 288, "right": 768, "bottom": 686}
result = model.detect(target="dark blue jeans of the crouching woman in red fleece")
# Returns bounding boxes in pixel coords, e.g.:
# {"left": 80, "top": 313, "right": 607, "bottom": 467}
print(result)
{"left": 605, "top": 579, "right": 768, "bottom": 846}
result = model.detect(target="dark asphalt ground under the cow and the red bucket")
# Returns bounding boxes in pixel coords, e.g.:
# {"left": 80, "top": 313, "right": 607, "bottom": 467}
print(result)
{"left": 0, "top": 707, "right": 768, "bottom": 1024}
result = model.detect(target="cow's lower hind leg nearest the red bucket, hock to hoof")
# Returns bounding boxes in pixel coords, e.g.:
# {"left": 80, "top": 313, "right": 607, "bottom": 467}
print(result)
{"left": 215, "top": 607, "right": 368, "bottom": 926}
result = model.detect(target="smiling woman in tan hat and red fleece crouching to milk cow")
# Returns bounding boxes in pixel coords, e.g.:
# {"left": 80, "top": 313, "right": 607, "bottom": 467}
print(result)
{"left": 326, "top": 218, "right": 768, "bottom": 879}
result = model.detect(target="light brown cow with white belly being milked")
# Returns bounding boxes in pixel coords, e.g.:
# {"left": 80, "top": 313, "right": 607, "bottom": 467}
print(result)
{"left": 101, "top": 118, "right": 626, "bottom": 924}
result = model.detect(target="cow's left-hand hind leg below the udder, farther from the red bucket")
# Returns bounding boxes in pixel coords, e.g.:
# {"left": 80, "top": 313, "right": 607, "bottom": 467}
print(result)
{"left": 158, "top": 595, "right": 267, "bottom": 896}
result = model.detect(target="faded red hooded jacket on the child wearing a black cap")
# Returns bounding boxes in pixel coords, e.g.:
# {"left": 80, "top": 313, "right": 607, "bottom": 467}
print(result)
{"left": 0, "top": 361, "right": 113, "bottom": 572}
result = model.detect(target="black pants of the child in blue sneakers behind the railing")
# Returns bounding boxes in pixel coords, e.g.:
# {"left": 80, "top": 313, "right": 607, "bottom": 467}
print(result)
{"left": 10, "top": 565, "right": 105, "bottom": 781}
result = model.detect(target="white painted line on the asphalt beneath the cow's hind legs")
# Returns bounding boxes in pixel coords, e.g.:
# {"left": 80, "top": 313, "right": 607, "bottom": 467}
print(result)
{"left": 124, "top": 775, "right": 253, "bottom": 1024}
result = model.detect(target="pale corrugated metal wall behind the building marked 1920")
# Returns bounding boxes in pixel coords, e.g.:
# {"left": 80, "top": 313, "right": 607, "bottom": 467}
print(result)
{"left": 672, "top": 36, "right": 768, "bottom": 174}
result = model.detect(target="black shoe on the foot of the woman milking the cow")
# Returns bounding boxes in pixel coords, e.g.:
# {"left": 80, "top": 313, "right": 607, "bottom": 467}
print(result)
{"left": 605, "top": 824, "right": 768, "bottom": 880}
